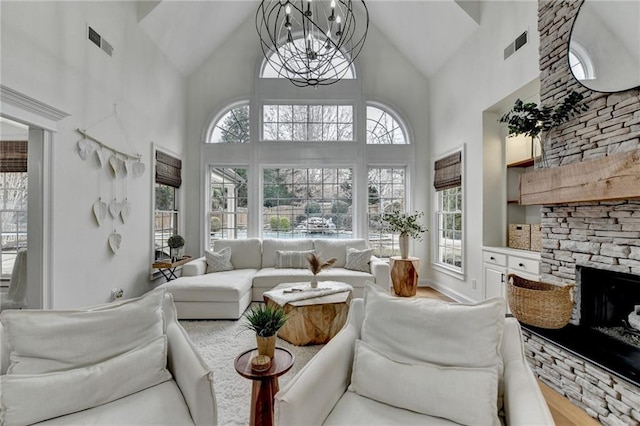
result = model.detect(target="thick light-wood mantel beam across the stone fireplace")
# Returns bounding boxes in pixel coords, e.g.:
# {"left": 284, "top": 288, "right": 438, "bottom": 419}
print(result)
{"left": 520, "top": 150, "right": 640, "bottom": 206}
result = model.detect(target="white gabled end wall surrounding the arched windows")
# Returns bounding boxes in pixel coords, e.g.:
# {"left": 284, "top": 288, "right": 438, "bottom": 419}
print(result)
{"left": 185, "top": 16, "right": 430, "bottom": 266}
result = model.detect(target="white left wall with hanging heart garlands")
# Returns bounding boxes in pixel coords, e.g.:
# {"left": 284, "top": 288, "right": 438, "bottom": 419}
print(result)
{"left": 0, "top": 1, "right": 186, "bottom": 308}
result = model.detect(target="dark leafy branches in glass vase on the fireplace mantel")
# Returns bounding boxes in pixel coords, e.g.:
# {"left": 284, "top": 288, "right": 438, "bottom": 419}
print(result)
{"left": 500, "top": 91, "right": 589, "bottom": 167}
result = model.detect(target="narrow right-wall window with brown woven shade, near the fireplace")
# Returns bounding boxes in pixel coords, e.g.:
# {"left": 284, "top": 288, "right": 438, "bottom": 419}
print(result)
{"left": 434, "top": 151, "right": 464, "bottom": 273}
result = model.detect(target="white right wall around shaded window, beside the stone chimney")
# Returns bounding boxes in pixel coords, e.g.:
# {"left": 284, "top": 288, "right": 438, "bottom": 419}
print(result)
{"left": 427, "top": 0, "right": 539, "bottom": 300}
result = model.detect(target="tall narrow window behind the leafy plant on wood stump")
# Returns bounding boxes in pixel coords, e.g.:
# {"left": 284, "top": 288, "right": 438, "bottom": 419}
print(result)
{"left": 367, "top": 167, "right": 407, "bottom": 258}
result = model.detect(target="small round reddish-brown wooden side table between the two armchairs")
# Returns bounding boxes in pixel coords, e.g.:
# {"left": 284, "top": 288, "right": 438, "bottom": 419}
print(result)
{"left": 234, "top": 348, "right": 295, "bottom": 426}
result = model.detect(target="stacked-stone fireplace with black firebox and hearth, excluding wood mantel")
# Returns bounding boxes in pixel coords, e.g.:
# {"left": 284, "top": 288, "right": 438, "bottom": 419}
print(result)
{"left": 523, "top": 0, "right": 640, "bottom": 425}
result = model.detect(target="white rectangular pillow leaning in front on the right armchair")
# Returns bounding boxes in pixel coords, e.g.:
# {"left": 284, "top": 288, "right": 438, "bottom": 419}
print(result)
{"left": 349, "top": 340, "right": 500, "bottom": 426}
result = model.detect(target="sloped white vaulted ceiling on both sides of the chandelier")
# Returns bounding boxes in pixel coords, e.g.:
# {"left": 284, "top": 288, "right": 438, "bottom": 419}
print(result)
{"left": 139, "top": 0, "right": 480, "bottom": 77}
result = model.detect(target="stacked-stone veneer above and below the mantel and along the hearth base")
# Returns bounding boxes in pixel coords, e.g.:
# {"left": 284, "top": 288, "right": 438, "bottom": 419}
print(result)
{"left": 525, "top": 0, "right": 640, "bottom": 425}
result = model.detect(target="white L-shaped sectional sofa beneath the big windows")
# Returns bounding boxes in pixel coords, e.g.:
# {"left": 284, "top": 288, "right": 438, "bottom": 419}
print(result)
{"left": 161, "top": 238, "right": 390, "bottom": 319}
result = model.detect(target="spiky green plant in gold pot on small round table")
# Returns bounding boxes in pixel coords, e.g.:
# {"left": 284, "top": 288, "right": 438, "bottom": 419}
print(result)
{"left": 244, "top": 303, "right": 287, "bottom": 358}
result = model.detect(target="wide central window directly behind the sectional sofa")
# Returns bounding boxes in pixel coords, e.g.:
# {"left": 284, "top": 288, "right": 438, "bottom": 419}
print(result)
{"left": 262, "top": 168, "right": 353, "bottom": 238}
